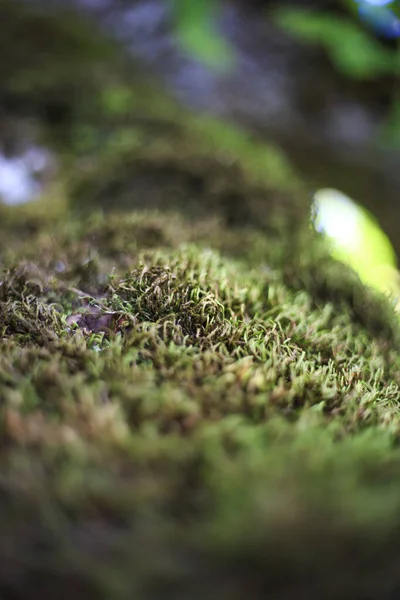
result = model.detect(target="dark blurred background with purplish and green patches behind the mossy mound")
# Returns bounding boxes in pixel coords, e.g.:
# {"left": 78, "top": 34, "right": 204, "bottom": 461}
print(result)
{"left": 0, "top": 0, "right": 400, "bottom": 248}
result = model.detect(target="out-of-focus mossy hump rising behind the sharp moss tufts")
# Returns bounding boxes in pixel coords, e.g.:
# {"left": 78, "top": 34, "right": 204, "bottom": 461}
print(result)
{"left": 69, "top": 77, "right": 309, "bottom": 239}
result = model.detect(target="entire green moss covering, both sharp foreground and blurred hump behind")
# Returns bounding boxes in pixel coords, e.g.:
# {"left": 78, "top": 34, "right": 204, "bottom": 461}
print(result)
{"left": 0, "top": 2, "right": 400, "bottom": 600}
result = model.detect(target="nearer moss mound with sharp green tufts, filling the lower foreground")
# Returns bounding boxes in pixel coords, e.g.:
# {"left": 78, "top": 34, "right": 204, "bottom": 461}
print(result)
{"left": 0, "top": 204, "right": 400, "bottom": 600}
